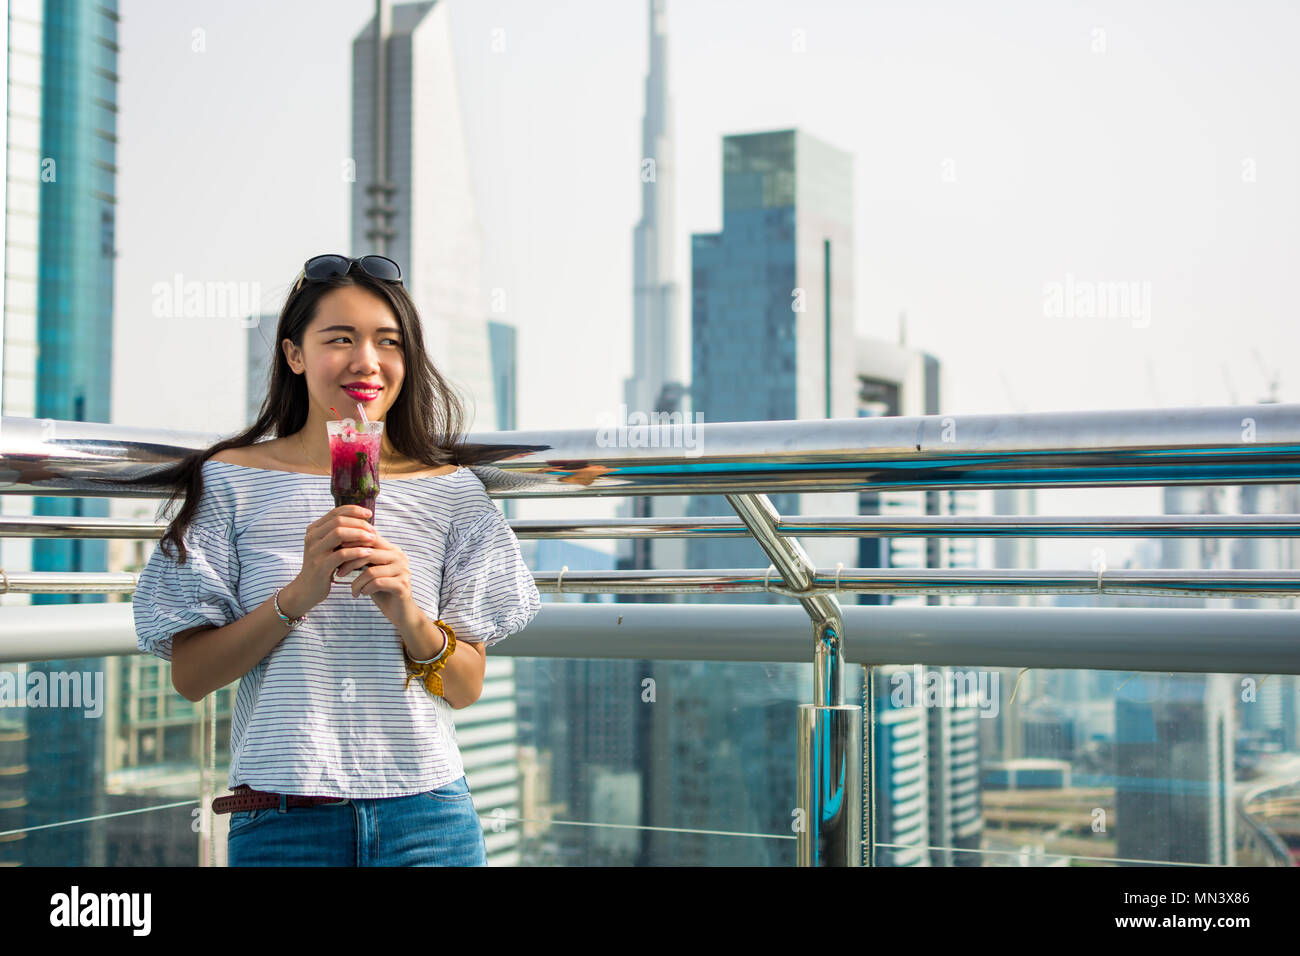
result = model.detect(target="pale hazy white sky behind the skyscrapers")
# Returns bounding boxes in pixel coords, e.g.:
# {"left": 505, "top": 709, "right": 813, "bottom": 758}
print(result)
{"left": 113, "top": 0, "right": 1300, "bottom": 566}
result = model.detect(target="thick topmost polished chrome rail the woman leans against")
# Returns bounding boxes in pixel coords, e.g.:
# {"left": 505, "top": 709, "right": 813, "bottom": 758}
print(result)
{"left": 0, "top": 405, "right": 1300, "bottom": 498}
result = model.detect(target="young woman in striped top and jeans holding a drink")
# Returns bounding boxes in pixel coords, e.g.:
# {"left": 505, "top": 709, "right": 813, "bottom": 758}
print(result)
{"left": 134, "top": 255, "right": 541, "bottom": 866}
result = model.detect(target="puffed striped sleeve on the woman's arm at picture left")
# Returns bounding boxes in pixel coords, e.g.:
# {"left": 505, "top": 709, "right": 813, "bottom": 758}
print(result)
{"left": 131, "top": 523, "right": 243, "bottom": 661}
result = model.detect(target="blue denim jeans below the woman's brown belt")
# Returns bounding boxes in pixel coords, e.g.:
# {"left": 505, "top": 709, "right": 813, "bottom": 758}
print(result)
{"left": 226, "top": 777, "right": 488, "bottom": 866}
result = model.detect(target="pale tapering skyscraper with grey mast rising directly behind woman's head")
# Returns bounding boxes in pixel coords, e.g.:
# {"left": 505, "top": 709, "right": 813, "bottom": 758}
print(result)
{"left": 351, "top": 0, "right": 498, "bottom": 431}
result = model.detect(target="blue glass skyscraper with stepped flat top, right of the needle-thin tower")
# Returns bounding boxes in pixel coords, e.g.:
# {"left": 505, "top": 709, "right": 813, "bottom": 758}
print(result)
{"left": 688, "top": 130, "right": 857, "bottom": 587}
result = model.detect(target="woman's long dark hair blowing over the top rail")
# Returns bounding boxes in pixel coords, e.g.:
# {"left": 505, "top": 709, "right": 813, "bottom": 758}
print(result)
{"left": 120, "top": 265, "right": 501, "bottom": 564}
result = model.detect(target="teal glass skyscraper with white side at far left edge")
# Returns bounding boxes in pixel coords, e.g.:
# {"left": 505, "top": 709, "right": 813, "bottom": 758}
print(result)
{"left": 0, "top": 0, "right": 118, "bottom": 866}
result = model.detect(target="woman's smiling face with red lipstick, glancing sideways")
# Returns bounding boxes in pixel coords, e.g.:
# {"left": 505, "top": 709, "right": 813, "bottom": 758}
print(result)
{"left": 283, "top": 285, "right": 406, "bottom": 420}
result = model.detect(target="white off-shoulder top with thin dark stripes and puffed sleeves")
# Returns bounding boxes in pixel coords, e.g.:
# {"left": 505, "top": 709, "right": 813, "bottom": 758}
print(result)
{"left": 133, "top": 459, "right": 541, "bottom": 797}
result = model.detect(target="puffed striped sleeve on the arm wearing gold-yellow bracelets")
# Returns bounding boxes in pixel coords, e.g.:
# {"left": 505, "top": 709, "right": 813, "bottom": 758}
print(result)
{"left": 438, "top": 506, "right": 542, "bottom": 648}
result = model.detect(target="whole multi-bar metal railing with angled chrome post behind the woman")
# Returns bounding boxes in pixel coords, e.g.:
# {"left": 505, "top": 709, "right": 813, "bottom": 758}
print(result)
{"left": 0, "top": 405, "right": 1300, "bottom": 865}
